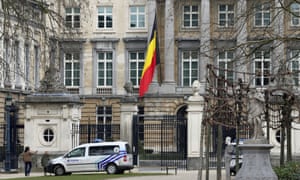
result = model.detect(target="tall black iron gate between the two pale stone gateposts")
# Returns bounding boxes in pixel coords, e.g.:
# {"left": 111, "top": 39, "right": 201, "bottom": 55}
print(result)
{"left": 132, "top": 115, "right": 187, "bottom": 169}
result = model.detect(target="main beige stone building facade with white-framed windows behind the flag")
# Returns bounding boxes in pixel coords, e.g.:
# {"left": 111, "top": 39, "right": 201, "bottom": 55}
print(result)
{"left": 0, "top": 0, "right": 300, "bottom": 169}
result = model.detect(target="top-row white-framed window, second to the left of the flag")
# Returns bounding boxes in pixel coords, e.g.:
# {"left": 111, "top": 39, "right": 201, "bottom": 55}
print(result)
{"left": 97, "top": 6, "right": 113, "bottom": 29}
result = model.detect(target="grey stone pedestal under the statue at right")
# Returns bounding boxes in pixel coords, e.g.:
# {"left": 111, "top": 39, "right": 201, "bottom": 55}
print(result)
{"left": 235, "top": 144, "right": 278, "bottom": 180}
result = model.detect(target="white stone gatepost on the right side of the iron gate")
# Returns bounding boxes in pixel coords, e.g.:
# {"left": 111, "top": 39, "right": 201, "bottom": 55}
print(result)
{"left": 187, "top": 83, "right": 204, "bottom": 170}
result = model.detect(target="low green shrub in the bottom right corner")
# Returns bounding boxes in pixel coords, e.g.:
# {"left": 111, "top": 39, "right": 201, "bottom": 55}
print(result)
{"left": 274, "top": 162, "right": 300, "bottom": 180}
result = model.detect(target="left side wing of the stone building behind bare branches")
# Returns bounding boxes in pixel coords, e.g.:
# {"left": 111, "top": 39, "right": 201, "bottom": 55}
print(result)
{"left": 0, "top": 1, "right": 49, "bottom": 144}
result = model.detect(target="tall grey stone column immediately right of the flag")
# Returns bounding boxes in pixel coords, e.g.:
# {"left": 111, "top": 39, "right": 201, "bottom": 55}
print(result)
{"left": 161, "top": 0, "right": 176, "bottom": 94}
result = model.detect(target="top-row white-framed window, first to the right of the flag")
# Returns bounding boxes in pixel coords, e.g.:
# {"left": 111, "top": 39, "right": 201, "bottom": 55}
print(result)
{"left": 183, "top": 5, "right": 199, "bottom": 28}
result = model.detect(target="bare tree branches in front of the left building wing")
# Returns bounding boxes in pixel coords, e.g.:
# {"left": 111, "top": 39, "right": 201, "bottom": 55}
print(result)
{"left": 0, "top": 0, "right": 89, "bottom": 89}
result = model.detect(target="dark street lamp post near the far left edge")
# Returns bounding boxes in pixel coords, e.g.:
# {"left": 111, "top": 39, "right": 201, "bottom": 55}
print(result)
{"left": 4, "top": 94, "right": 12, "bottom": 172}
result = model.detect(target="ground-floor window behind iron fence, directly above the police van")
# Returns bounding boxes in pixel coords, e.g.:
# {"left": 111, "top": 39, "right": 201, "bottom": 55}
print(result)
{"left": 96, "top": 106, "right": 112, "bottom": 140}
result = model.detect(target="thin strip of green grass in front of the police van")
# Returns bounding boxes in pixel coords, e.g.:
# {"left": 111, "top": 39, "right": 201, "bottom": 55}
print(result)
{"left": 9, "top": 173, "right": 163, "bottom": 180}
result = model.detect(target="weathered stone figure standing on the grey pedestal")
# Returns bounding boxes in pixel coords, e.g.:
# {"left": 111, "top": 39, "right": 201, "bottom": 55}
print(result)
{"left": 247, "top": 90, "right": 265, "bottom": 140}
